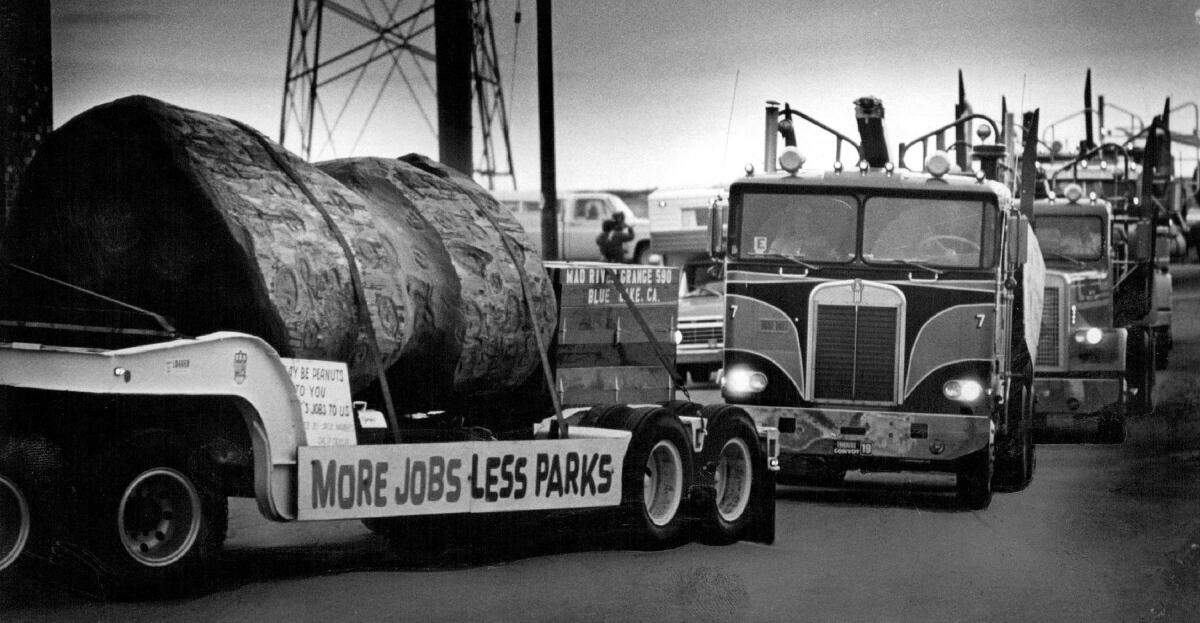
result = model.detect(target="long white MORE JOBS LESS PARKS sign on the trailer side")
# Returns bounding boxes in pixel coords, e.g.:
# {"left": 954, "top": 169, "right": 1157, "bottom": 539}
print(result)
{"left": 296, "top": 429, "right": 630, "bottom": 520}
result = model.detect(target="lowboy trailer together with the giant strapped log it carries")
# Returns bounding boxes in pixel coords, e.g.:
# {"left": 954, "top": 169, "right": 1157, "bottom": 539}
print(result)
{"left": 0, "top": 97, "right": 778, "bottom": 594}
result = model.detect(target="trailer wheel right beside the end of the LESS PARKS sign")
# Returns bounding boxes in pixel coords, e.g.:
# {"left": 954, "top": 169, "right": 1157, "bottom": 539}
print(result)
{"left": 622, "top": 408, "right": 691, "bottom": 546}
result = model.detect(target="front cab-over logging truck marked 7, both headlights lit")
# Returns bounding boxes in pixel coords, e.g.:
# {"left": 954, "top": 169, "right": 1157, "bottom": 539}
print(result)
{"left": 710, "top": 97, "right": 1042, "bottom": 509}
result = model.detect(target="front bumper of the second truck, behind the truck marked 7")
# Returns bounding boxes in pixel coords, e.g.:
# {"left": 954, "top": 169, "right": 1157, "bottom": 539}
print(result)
{"left": 1033, "top": 377, "right": 1126, "bottom": 427}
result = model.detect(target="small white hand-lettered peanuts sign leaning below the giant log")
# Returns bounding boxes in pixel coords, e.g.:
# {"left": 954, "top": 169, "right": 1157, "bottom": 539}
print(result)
{"left": 283, "top": 359, "right": 358, "bottom": 445}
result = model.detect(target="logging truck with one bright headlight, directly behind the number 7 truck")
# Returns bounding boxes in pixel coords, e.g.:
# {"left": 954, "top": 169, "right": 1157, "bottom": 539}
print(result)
{"left": 1034, "top": 100, "right": 1172, "bottom": 443}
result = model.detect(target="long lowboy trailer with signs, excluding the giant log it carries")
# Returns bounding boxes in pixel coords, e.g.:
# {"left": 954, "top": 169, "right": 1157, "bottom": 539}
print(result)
{"left": 0, "top": 264, "right": 779, "bottom": 594}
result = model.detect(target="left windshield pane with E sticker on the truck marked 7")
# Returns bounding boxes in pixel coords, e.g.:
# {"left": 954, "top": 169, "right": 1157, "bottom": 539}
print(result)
{"left": 739, "top": 193, "right": 858, "bottom": 262}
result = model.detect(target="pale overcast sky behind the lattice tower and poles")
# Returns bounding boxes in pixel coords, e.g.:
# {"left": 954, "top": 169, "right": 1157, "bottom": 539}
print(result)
{"left": 52, "top": 0, "right": 1200, "bottom": 190}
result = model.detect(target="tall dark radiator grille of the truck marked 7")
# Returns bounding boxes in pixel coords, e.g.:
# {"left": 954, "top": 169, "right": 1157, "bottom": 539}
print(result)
{"left": 812, "top": 305, "right": 898, "bottom": 402}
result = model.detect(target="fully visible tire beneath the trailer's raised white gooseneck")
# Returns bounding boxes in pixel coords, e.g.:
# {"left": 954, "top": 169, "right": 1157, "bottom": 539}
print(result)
{"left": 84, "top": 432, "right": 228, "bottom": 598}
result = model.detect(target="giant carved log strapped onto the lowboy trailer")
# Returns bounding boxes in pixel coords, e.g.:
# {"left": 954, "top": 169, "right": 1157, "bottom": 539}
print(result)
{"left": 0, "top": 96, "right": 554, "bottom": 422}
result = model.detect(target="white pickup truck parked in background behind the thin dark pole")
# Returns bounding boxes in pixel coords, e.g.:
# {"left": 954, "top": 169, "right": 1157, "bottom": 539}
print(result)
{"left": 492, "top": 191, "right": 650, "bottom": 264}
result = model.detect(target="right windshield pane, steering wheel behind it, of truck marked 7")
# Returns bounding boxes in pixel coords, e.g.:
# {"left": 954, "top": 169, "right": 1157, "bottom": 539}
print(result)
{"left": 863, "top": 197, "right": 995, "bottom": 268}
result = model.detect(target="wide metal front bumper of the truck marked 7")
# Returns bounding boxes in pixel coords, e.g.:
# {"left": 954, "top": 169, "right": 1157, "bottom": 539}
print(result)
{"left": 743, "top": 406, "right": 994, "bottom": 475}
